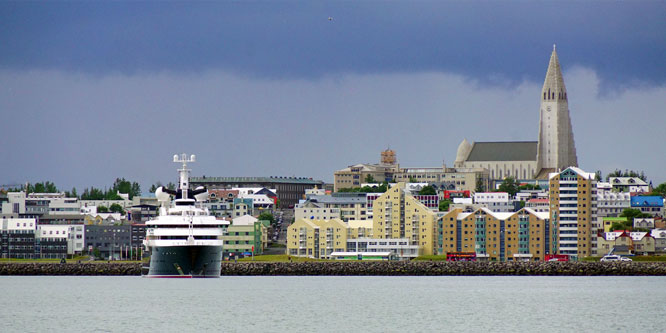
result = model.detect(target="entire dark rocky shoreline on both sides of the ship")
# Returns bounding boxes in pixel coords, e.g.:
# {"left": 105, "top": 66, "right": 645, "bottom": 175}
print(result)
{"left": 0, "top": 261, "right": 666, "bottom": 276}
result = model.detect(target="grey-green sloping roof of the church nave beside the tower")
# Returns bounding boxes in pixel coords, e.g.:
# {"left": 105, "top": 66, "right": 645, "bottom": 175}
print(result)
{"left": 467, "top": 141, "right": 537, "bottom": 162}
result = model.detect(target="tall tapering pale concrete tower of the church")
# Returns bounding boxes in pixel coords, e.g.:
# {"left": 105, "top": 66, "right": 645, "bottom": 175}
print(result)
{"left": 537, "top": 45, "right": 578, "bottom": 175}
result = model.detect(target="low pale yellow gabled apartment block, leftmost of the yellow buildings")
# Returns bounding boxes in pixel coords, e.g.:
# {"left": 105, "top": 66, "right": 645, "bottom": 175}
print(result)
{"left": 287, "top": 219, "right": 348, "bottom": 259}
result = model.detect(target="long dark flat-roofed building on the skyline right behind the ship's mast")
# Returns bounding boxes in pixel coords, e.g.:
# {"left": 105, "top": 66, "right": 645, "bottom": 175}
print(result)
{"left": 190, "top": 176, "right": 324, "bottom": 208}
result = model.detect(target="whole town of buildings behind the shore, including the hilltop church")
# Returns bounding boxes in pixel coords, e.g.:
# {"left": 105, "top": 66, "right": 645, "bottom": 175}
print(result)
{"left": 0, "top": 47, "right": 666, "bottom": 262}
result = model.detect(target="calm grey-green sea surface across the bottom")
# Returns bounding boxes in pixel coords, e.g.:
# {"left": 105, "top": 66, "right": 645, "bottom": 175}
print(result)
{"left": 0, "top": 276, "right": 666, "bottom": 332}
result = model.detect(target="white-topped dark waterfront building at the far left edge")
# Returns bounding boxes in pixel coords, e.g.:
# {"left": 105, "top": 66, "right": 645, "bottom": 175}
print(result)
{"left": 0, "top": 218, "right": 37, "bottom": 259}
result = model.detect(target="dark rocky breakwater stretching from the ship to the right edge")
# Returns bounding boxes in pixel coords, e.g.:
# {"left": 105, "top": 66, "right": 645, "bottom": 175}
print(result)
{"left": 222, "top": 261, "right": 666, "bottom": 276}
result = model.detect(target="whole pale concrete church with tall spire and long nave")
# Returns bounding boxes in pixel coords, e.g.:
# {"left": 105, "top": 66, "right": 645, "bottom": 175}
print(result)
{"left": 454, "top": 45, "right": 578, "bottom": 179}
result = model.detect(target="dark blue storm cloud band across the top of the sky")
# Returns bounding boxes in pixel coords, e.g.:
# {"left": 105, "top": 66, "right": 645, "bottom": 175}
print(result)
{"left": 0, "top": 1, "right": 666, "bottom": 88}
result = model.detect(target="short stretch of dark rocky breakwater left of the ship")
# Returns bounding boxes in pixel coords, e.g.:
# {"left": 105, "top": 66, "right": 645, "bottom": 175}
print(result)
{"left": 0, "top": 263, "right": 141, "bottom": 275}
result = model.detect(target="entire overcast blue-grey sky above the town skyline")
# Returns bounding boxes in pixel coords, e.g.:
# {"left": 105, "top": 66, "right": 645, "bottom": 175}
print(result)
{"left": 0, "top": 1, "right": 666, "bottom": 192}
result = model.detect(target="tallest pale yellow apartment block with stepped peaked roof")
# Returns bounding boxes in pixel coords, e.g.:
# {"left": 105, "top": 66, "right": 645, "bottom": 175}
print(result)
{"left": 373, "top": 183, "right": 437, "bottom": 255}
